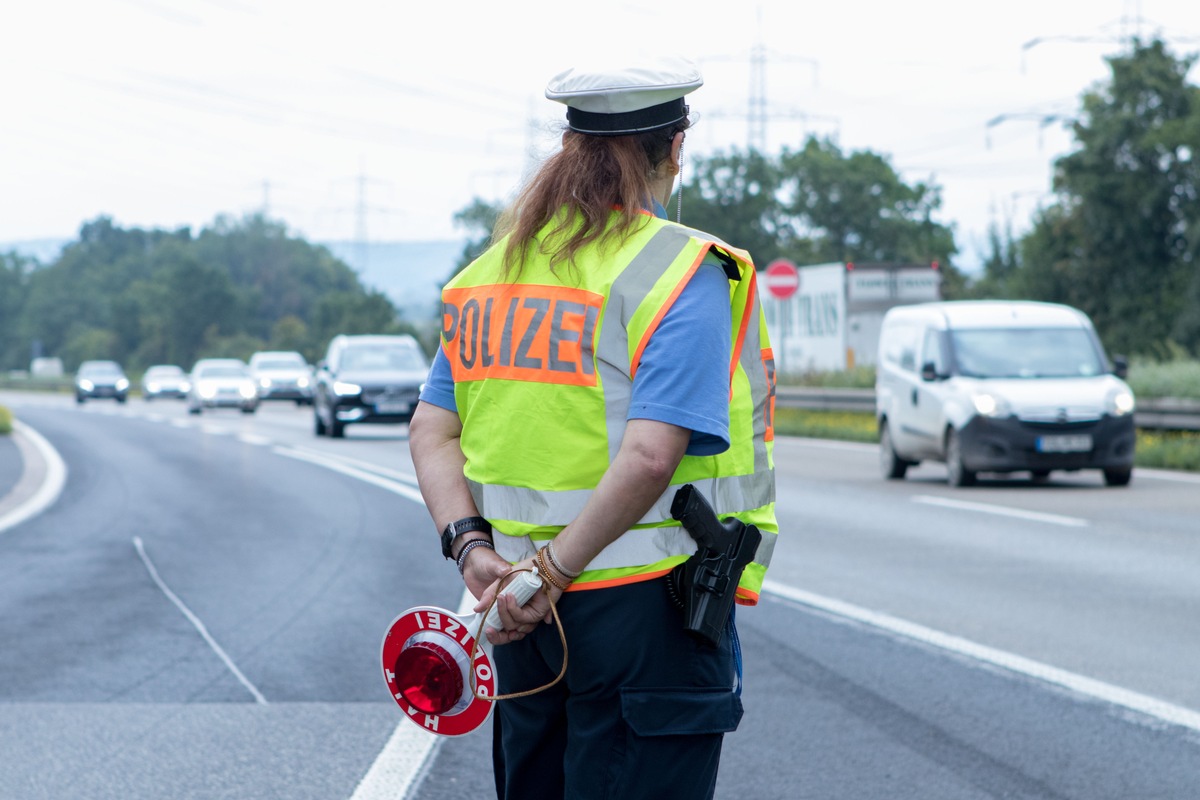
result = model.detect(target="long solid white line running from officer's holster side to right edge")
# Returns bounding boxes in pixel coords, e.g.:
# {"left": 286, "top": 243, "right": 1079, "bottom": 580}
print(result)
{"left": 763, "top": 581, "right": 1200, "bottom": 732}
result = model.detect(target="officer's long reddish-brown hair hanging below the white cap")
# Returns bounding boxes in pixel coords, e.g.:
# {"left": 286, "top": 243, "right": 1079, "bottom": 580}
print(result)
{"left": 494, "top": 119, "right": 689, "bottom": 277}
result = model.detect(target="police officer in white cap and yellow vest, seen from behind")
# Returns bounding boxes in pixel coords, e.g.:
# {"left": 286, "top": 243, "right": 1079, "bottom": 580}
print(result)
{"left": 409, "top": 58, "right": 778, "bottom": 800}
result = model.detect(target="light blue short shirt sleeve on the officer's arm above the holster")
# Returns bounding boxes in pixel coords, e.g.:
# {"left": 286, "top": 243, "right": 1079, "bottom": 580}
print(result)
{"left": 628, "top": 261, "right": 733, "bottom": 456}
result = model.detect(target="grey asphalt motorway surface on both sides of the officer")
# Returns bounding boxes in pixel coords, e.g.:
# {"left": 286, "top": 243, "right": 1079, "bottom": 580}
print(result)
{"left": 0, "top": 396, "right": 1200, "bottom": 800}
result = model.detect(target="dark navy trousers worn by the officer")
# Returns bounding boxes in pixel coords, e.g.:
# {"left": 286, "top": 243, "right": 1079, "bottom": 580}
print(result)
{"left": 492, "top": 578, "right": 742, "bottom": 800}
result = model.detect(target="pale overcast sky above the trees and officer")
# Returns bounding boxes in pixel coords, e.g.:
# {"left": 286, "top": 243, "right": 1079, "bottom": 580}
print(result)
{"left": 0, "top": 0, "right": 1200, "bottom": 269}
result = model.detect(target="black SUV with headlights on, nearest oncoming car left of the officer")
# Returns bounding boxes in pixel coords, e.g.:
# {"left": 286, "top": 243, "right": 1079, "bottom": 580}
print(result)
{"left": 312, "top": 335, "right": 430, "bottom": 438}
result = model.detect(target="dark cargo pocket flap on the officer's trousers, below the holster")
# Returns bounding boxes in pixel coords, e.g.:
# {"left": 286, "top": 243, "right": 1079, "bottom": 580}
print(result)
{"left": 620, "top": 688, "right": 742, "bottom": 736}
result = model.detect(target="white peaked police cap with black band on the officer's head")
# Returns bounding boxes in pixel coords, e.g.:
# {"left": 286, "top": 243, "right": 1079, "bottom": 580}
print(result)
{"left": 546, "top": 56, "right": 704, "bottom": 136}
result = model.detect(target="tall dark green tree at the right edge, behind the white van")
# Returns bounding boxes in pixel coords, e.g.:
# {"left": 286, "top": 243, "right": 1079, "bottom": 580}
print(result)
{"left": 1021, "top": 40, "right": 1200, "bottom": 354}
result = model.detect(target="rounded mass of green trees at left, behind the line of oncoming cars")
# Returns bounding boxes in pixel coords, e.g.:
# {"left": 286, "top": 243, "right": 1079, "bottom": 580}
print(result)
{"left": 0, "top": 216, "right": 406, "bottom": 373}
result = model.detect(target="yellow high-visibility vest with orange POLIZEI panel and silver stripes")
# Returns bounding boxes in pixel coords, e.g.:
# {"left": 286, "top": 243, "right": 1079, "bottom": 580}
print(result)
{"left": 442, "top": 209, "right": 779, "bottom": 604}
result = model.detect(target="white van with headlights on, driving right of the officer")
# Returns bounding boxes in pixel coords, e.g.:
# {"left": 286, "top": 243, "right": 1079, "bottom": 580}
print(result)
{"left": 875, "top": 300, "right": 1135, "bottom": 486}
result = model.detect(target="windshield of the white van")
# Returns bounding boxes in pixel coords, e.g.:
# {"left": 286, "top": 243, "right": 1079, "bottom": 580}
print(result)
{"left": 950, "top": 327, "right": 1106, "bottom": 378}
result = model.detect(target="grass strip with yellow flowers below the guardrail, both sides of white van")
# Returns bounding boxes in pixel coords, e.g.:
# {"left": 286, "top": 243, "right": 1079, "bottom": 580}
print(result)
{"left": 775, "top": 408, "right": 1200, "bottom": 471}
